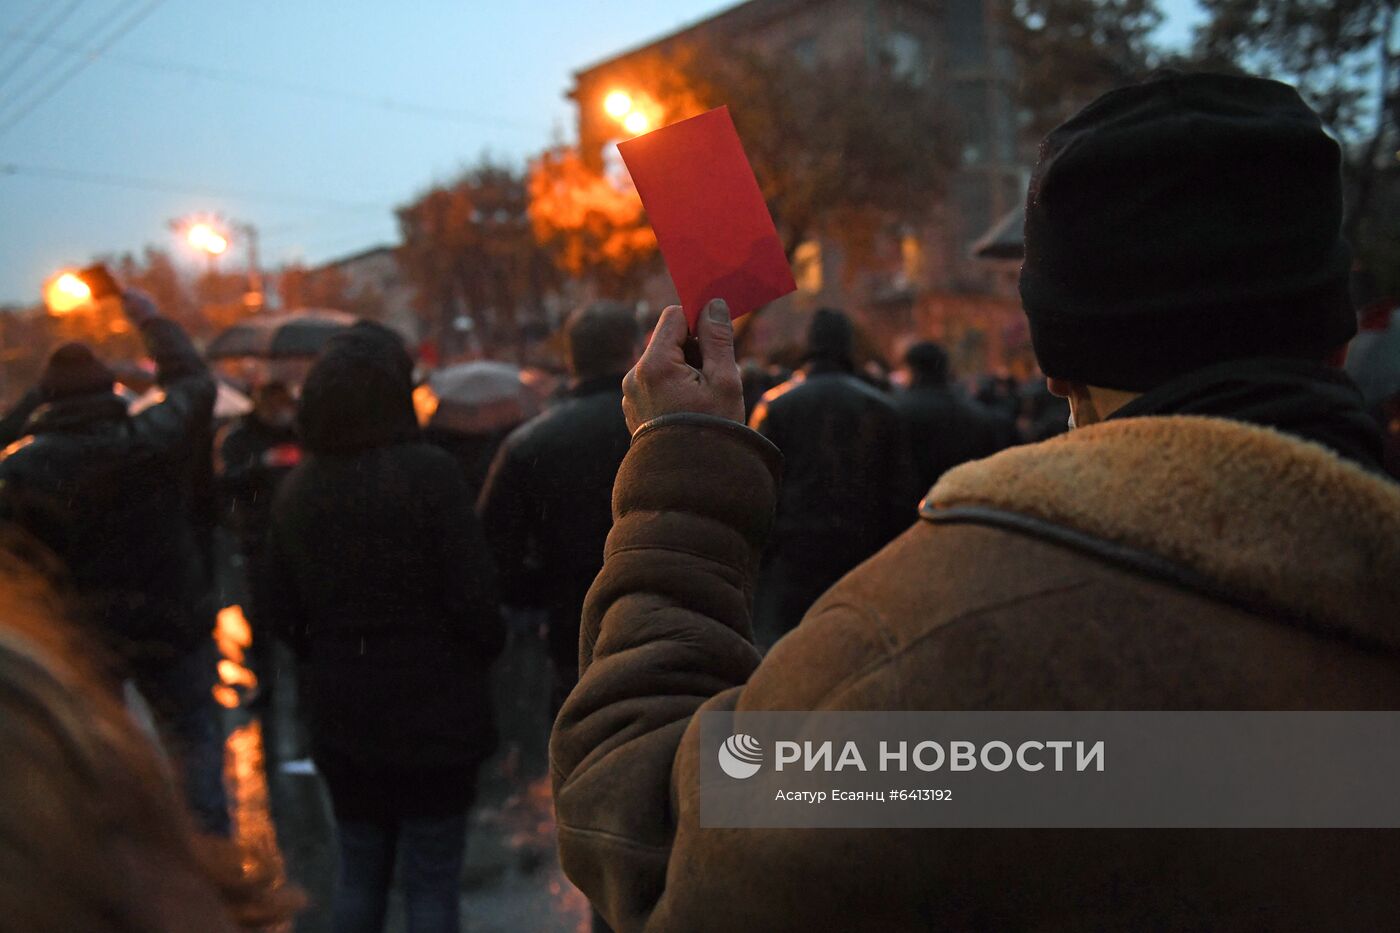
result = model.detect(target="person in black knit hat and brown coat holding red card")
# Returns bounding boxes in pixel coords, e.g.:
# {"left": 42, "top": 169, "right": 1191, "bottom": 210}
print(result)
{"left": 550, "top": 74, "right": 1400, "bottom": 933}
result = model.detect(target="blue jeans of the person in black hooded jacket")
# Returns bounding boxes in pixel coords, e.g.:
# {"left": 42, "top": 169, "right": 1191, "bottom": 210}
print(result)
{"left": 332, "top": 813, "right": 466, "bottom": 933}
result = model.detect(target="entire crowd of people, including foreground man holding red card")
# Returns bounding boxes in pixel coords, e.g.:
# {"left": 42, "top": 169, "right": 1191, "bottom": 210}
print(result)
{"left": 0, "top": 67, "right": 1400, "bottom": 933}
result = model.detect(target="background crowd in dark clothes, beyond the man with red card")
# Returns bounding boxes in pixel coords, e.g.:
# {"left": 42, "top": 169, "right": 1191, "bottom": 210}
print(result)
{"left": 0, "top": 270, "right": 1021, "bottom": 930}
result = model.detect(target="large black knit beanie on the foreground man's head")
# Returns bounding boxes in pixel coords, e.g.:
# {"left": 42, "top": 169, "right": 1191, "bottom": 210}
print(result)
{"left": 1021, "top": 71, "right": 1357, "bottom": 391}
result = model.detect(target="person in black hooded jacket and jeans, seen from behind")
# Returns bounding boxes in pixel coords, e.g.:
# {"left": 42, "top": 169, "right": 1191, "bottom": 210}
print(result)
{"left": 253, "top": 322, "right": 504, "bottom": 930}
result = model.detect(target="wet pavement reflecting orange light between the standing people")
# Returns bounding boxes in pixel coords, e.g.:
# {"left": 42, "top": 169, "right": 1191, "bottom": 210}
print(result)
{"left": 217, "top": 621, "right": 591, "bottom": 933}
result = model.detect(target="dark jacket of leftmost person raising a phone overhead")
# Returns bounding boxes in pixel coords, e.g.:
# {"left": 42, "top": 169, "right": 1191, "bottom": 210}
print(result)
{"left": 0, "top": 318, "right": 214, "bottom": 663}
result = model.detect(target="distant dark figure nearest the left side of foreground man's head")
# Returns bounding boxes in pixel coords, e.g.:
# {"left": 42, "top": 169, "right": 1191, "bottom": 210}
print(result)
{"left": 895, "top": 340, "right": 1018, "bottom": 490}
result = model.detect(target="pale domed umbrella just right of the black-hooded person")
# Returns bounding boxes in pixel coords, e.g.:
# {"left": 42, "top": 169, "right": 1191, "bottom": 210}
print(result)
{"left": 413, "top": 360, "right": 545, "bottom": 434}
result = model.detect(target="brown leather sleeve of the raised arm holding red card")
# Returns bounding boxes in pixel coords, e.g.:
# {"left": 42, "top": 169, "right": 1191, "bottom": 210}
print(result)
{"left": 550, "top": 415, "right": 781, "bottom": 930}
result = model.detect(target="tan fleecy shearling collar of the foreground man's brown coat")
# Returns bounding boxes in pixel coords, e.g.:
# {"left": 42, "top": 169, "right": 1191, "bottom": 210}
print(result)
{"left": 921, "top": 416, "right": 1400, "bottom": 647}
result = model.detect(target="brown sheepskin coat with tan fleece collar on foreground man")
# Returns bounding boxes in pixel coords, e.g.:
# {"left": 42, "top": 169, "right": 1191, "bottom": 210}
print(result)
{"left": 552, "top": 415, "right": 1400, "bottom": 933}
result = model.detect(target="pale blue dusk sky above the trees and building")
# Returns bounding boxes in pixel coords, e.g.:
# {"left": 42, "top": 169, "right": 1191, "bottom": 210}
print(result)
{"left": 0, "top": 0, "right": 1198, "bottom": 304}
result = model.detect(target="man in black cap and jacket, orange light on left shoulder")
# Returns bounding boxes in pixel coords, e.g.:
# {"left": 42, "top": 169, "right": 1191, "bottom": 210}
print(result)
{"left": 750, "top": 308, "right": 918, "bottom": 646}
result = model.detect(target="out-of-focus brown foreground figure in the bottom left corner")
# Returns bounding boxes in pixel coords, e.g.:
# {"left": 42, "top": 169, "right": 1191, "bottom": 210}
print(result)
{"left": 0, "top": 553, "right": 302, "bottom": 933}
